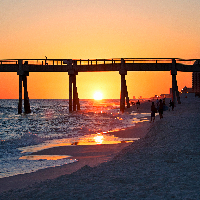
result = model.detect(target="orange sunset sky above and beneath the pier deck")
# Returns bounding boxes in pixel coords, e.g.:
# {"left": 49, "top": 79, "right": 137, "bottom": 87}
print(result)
{"left": 0, "top": 0, "right": 200, "bottom": 99}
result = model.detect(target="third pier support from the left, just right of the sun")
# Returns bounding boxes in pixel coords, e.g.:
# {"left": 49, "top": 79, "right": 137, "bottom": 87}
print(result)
{"left": 119, "top": 58, "right": 130, "bottom": 112}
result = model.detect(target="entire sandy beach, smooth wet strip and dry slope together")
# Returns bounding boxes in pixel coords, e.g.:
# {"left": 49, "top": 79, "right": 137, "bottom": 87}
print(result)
{"left": 0, "top": 97, "right": 200, "bottom": 199}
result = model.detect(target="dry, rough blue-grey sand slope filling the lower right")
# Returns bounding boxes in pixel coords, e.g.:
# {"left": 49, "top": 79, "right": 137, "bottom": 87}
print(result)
{"left": 0, "top": 98, "right": 200, "bottom": 199}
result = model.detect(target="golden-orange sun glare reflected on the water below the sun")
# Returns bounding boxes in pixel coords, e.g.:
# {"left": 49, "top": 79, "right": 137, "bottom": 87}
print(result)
{"left": 19, "top": 108, "right": 150, "bottom": 153}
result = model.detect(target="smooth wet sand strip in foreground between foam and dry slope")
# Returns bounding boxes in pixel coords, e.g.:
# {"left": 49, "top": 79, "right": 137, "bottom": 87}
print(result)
{"left": 0, "top": 143, "right": 129, "bottom": 193}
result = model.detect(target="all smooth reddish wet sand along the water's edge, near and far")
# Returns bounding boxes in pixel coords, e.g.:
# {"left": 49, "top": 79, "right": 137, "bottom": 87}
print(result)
{"left": 0, "top": 102, "right": 150, "bottom": 193}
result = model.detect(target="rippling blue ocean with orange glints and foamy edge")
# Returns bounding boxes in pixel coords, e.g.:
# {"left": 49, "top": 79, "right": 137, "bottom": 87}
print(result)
{"left": 0, "top": 99, "right": 150, "bottom": 178}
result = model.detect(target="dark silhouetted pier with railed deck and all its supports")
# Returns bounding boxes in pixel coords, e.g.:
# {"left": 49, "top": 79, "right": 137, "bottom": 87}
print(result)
{"left": 0, "top": 58, "right": 200, "bottom": 113}
